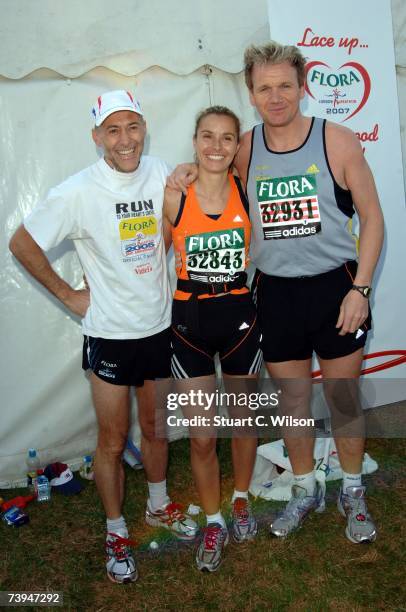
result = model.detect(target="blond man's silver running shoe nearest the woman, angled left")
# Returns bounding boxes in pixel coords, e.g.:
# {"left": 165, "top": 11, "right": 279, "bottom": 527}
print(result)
{"left": 270, "top": 483, "right": 326, "bottom": 538}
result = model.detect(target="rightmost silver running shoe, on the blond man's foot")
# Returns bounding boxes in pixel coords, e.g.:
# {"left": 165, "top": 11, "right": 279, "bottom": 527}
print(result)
{"left": 337, "top": 487, "right": 377, "bottom": 544}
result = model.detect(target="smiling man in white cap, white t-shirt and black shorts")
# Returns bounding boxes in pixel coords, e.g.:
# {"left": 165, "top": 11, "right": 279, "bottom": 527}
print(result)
{"left": 10, "top": 90, "right": 197, "bottom": 583}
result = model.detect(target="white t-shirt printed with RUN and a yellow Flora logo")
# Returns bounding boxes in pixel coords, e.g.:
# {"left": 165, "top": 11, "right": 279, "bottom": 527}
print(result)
{"left": 24, "top": 156, "right": 171, "bottom": 339}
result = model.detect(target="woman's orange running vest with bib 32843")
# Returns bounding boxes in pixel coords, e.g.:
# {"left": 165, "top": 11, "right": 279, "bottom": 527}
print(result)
{"left": 172, "top": 174, "right": 251, "bottom": 300}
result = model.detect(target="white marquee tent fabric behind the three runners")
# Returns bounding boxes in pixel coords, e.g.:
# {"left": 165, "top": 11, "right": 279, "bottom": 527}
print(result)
{"left": 0, "top": 0, "right": 406, "bottom": 487}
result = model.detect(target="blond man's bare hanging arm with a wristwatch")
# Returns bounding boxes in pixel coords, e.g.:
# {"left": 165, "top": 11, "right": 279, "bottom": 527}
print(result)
{"left": 326, "top": 126, "right": 383, "bottom": 335}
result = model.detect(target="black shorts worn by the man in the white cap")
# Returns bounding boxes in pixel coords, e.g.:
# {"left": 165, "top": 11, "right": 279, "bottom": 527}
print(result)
{"left": 82, "top": 327, "right": 171, "bottom": 387}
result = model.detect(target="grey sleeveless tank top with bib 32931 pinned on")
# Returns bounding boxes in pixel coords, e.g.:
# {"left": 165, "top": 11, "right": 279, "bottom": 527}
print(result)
{"left": 247, "top": 118, "right": 357, "bottom": 277}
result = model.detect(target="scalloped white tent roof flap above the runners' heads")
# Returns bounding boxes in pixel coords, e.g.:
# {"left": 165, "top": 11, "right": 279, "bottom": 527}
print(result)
{"left": 0, "top": 0, "right": 269, "bottom": 79}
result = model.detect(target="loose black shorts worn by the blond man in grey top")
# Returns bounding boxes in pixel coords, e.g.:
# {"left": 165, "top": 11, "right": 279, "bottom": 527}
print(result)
{"left": 252, "top": 261, "right": 371, "bottom": 363}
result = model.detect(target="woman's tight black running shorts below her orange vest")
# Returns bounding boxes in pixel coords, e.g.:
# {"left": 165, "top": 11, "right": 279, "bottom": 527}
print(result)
{"left": 171, "top": 293, "right": 262, "bottom": 379}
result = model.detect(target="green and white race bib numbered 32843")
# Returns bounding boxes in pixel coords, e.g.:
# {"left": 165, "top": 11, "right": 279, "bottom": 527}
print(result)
{"left": 185, "top": 228, "right": 245, "bottom": 283}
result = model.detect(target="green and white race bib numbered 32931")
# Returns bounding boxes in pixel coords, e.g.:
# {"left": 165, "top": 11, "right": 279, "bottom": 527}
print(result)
{"left": 257, "top": 174, "right": 321, "bottom": 240}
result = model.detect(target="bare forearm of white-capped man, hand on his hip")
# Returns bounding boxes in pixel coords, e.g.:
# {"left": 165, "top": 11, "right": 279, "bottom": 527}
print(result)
{"left": 9, "top": 225, "right": 90, "bottom": 317}
